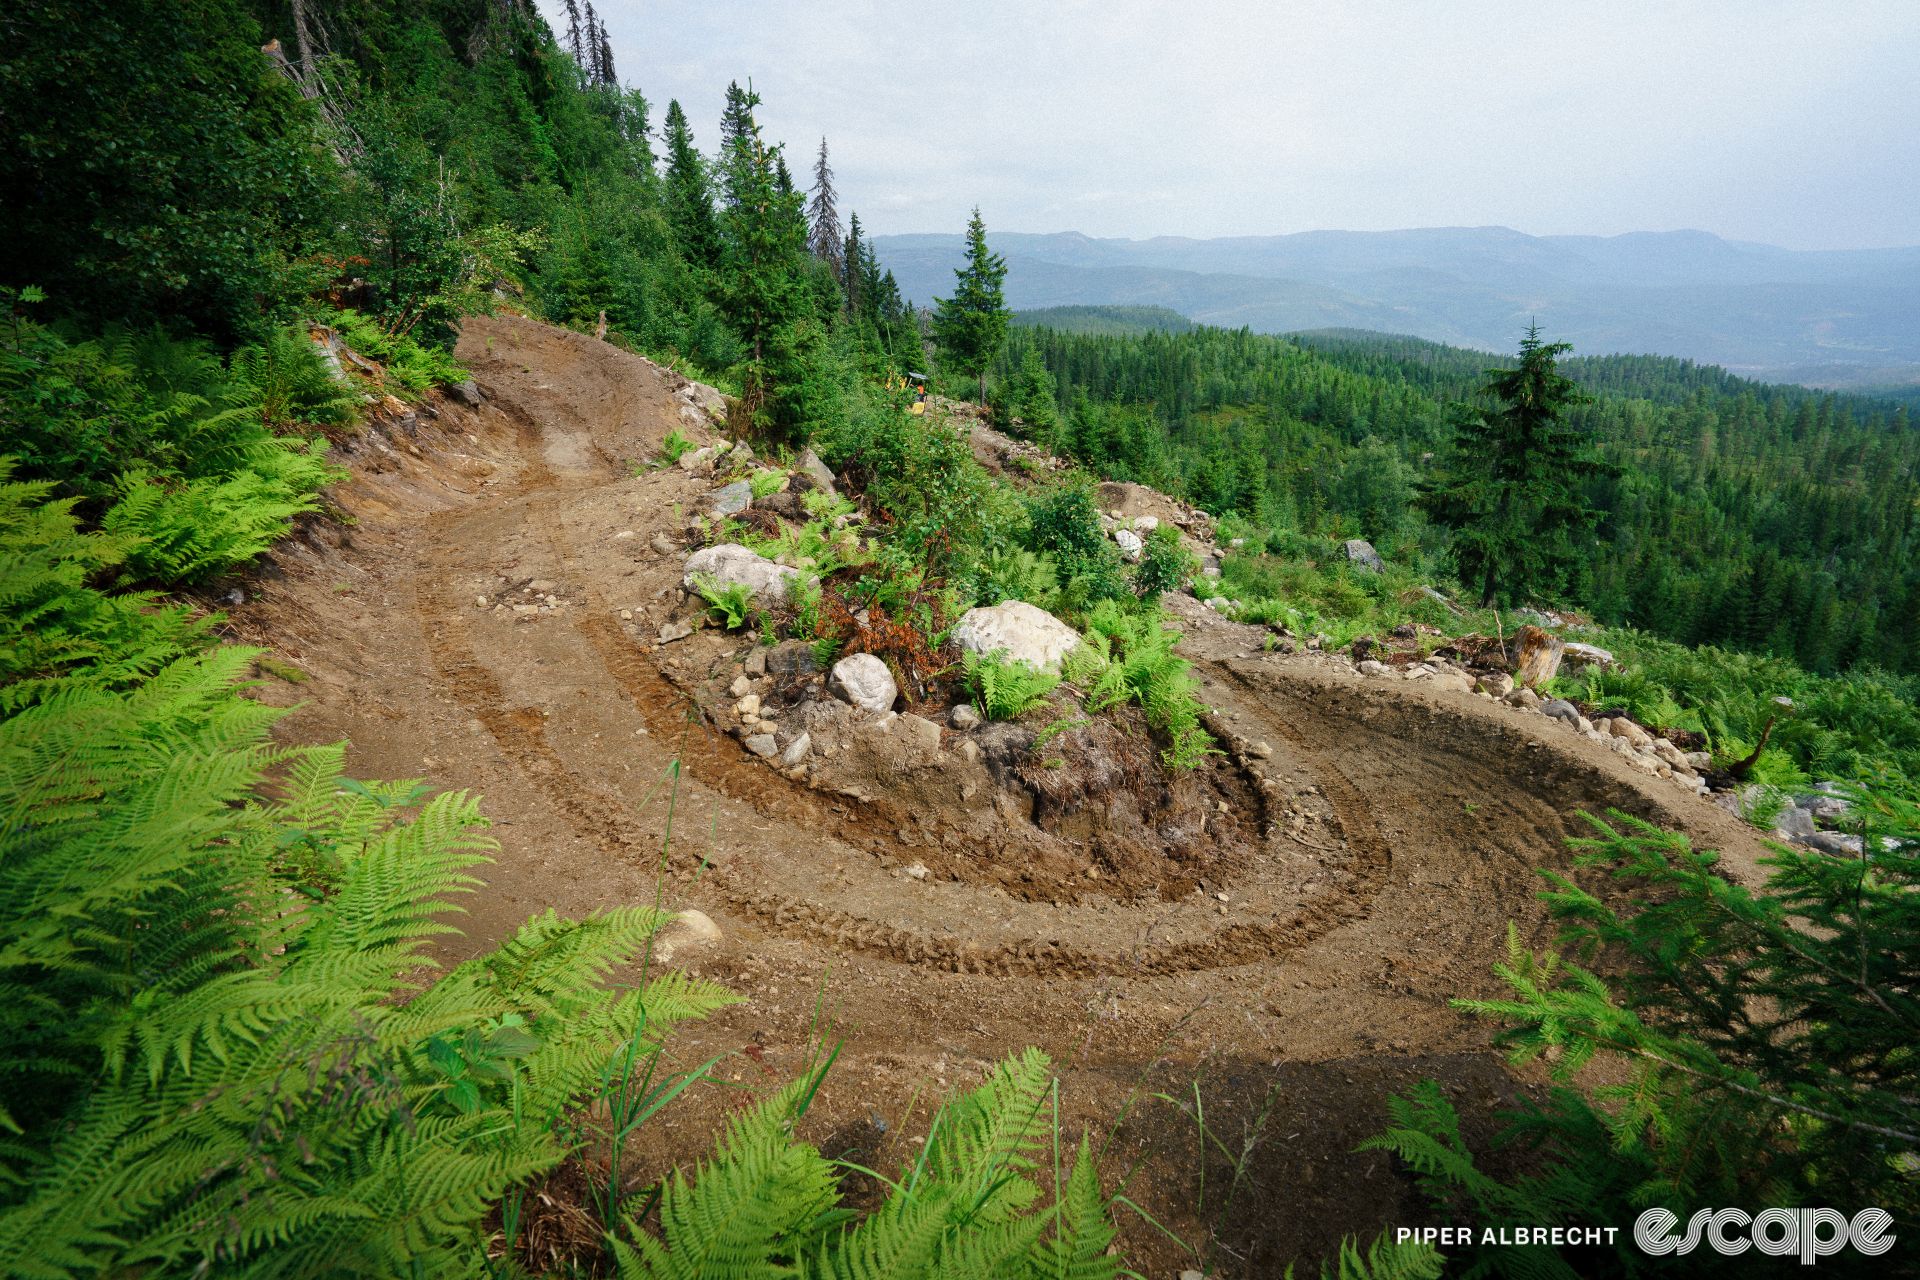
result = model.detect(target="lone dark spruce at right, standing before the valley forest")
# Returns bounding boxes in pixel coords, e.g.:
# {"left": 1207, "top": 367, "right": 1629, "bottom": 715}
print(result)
{"left": 1421, "top": 324, "right": 1609, "bottom": 606}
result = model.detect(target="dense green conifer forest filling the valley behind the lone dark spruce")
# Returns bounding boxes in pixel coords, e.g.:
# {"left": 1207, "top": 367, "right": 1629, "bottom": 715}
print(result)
{"left": 1004, "top": 328, "right": 1920, "bottom": 672}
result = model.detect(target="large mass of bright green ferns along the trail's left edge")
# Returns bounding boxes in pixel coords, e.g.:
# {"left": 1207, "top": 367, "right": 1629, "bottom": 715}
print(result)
{"left": 0, "top": 475, "right": 728, "bottom": 1276}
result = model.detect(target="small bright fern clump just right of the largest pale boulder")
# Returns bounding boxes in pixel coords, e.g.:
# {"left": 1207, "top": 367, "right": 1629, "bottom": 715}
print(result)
{"left": 1062, "top": 601, "right": 1215, "bottom": 770}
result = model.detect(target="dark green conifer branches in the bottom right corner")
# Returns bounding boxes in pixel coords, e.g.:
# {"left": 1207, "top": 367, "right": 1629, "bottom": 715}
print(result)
{"left": 1367, "top": 794, "right": 1920, "bottom": 1276}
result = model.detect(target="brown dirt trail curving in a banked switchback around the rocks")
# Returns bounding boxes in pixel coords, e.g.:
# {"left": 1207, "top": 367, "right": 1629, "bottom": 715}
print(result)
{"left": 236, "top": 319, "right": 1759, "bottom": 1274}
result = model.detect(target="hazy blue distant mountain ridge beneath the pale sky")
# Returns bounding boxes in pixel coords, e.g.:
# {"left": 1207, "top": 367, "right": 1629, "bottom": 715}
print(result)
{"left": 874, "top": 226, "right": 1920, "bottom": 388}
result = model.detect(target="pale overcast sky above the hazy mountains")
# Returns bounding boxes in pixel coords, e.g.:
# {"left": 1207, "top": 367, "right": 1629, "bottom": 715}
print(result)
{"left": 540, "top": 0, "right": 1920, "bottom": 248}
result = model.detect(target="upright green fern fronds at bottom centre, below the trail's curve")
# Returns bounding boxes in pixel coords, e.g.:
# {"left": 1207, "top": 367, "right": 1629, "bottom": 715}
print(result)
{"left": 616, "top": 1050, "right": 1119, "bottom": 1280}
